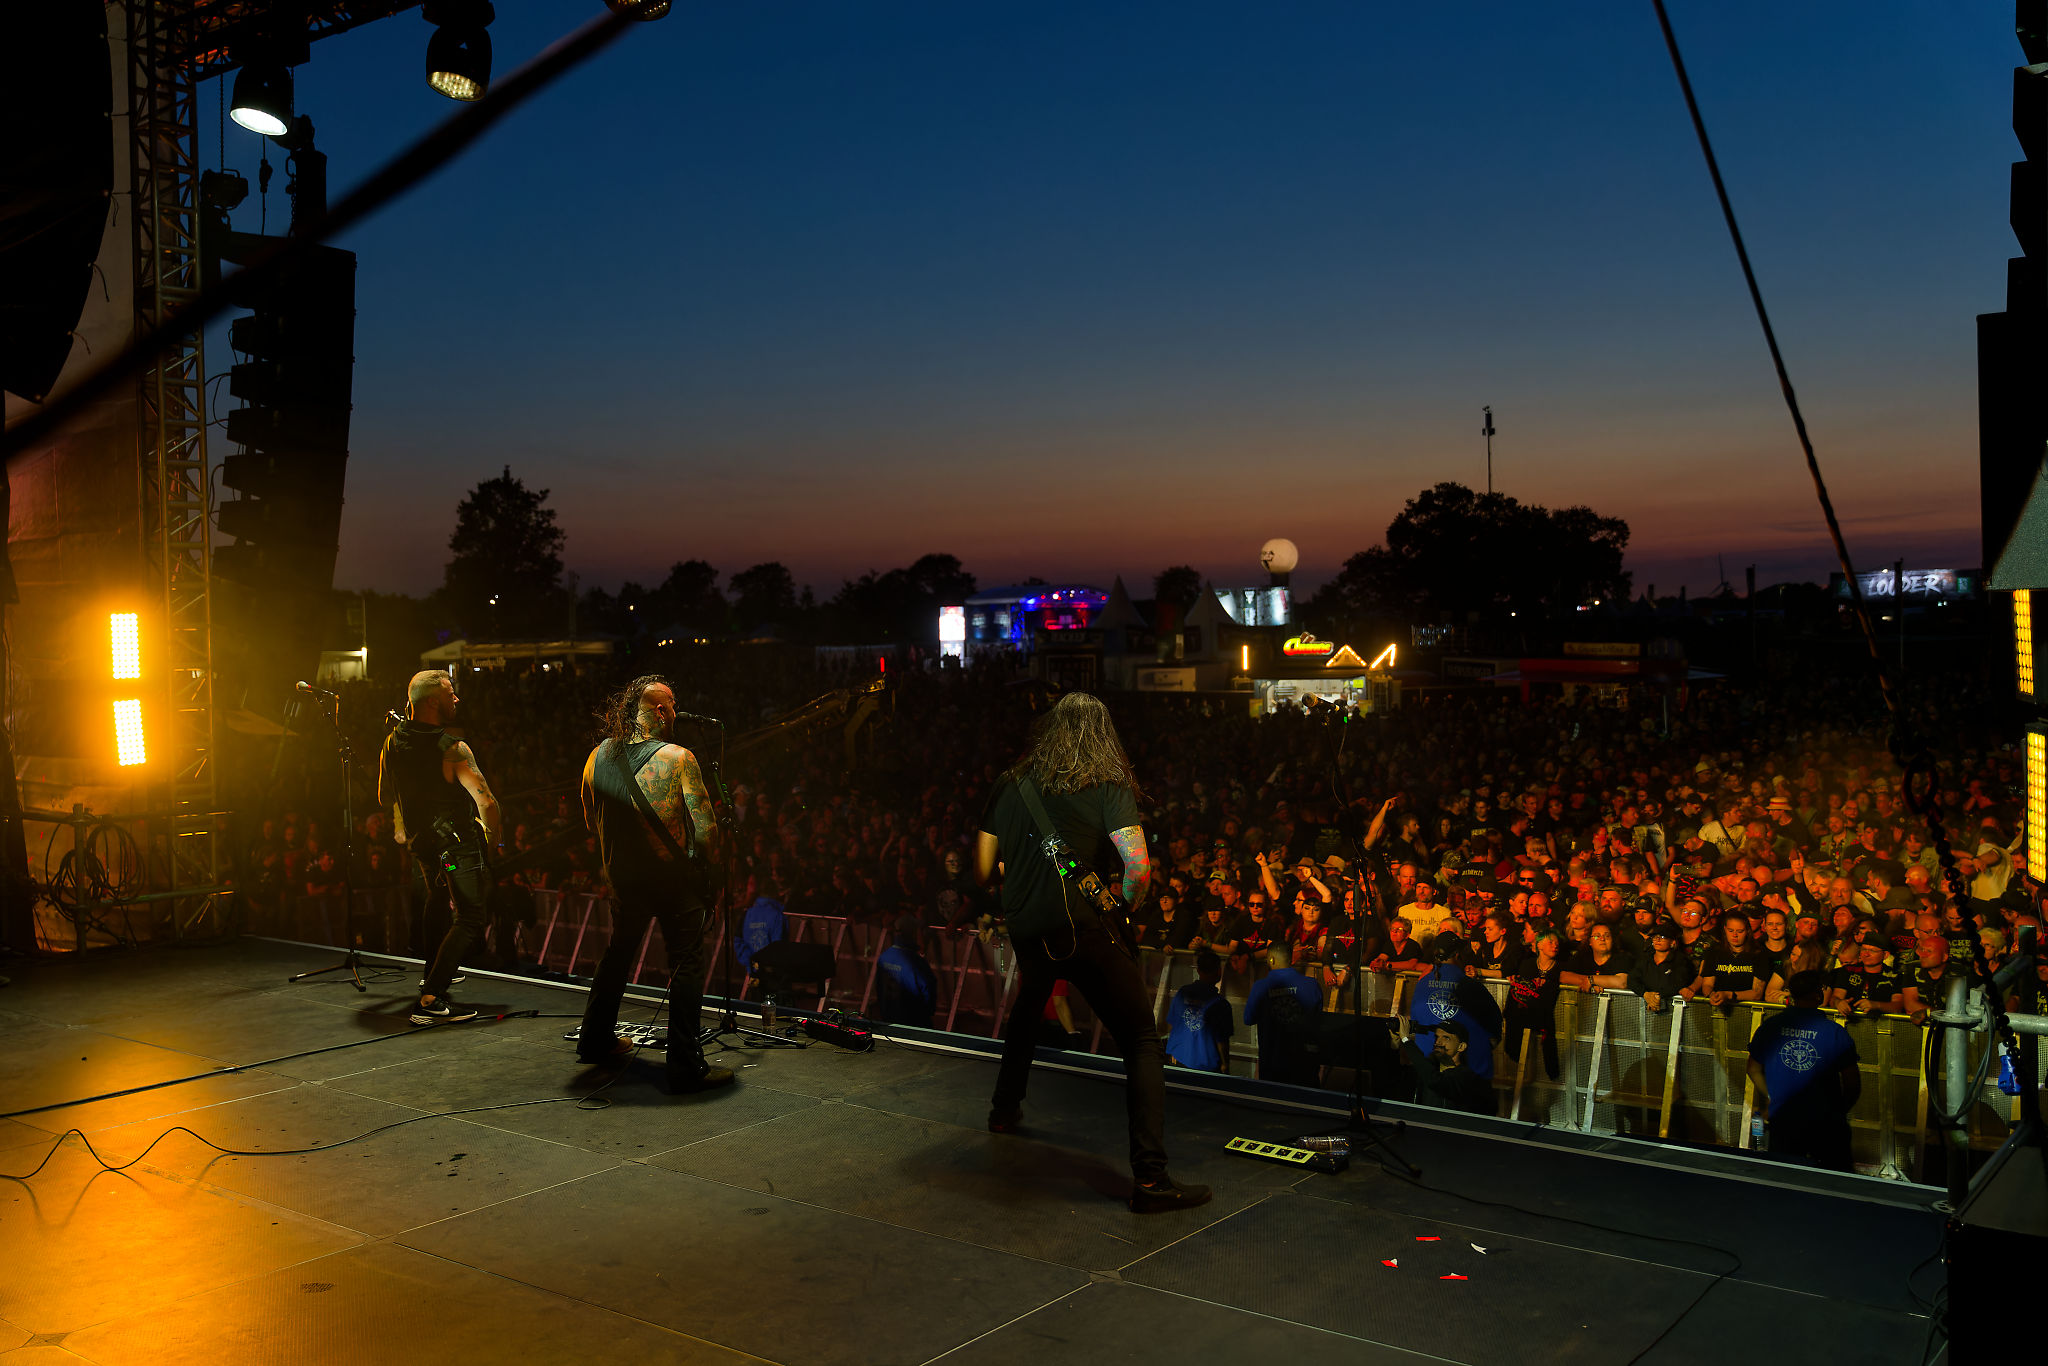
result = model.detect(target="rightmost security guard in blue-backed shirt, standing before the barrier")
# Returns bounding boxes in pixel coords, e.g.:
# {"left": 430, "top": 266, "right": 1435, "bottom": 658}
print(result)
{"left": 1749, "top": 973, "right": 1864, "bottom": 1171}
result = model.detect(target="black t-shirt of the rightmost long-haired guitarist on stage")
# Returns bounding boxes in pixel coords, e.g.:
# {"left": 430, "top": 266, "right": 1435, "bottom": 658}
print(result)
{"left": 981, "top": 782, "right": 1139, "bottom": 938}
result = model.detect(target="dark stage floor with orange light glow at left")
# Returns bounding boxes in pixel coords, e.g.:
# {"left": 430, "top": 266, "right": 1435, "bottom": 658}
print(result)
{"left": 0, "top": 940, "right": 1939, "bottom": 1366}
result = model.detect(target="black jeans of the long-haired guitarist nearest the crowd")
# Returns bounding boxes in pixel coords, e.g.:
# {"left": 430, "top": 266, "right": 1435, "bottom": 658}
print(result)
{"left": 991, "top": 926, "right": 1165, "bottom": 1182}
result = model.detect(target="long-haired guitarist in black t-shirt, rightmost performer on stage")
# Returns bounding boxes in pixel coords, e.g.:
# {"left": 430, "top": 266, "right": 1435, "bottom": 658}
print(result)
{"left": 975, "top": 692, "right": 1208, "bottom": 1214}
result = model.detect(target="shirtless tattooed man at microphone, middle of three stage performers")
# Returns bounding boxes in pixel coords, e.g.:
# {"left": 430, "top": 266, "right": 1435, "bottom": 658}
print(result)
{"left": 575, "top": 674, "right": 733, "bottom": 1096}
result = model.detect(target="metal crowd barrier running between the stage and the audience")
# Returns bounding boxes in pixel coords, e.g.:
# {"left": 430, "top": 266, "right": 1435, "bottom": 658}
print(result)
{"left": 272, "top": 889, "right": 2048, "bottom": 1180}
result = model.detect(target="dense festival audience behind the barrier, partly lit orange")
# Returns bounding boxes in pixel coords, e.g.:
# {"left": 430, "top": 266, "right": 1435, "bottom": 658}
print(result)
{"left": 242, "top": 649, "right": 2042, "bottom": 1130}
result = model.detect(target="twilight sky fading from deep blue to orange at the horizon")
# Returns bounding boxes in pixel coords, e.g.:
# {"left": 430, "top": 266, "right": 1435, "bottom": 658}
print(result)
{"left": 203, "top": 0, "right": 2021, "bottom": 596}
